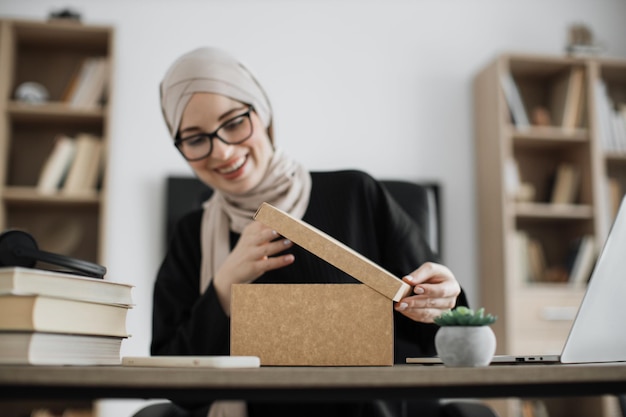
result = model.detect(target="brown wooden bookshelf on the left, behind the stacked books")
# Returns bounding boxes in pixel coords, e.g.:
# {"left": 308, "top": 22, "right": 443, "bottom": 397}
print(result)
{"left": 0, "top": 19, "right": 114, "bottom": 270}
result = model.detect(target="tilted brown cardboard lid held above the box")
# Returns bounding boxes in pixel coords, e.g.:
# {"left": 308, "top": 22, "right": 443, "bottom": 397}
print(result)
{"left": 254, "top": 203, "right": 411, "bottom": 301}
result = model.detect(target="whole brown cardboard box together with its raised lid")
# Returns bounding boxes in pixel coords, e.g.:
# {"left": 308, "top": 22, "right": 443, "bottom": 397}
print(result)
{"left": 230, "top": 203, "right": 411, "bottom": 366}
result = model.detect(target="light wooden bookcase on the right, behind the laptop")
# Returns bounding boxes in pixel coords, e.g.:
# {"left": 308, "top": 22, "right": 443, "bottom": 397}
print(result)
{"left": 473, "top": 54, "right": 626, "bottom": 417}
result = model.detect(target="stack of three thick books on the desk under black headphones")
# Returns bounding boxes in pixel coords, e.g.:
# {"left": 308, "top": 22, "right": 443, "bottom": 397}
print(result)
{"left": 0, "top": 267, "right": 133, "bottom": 365}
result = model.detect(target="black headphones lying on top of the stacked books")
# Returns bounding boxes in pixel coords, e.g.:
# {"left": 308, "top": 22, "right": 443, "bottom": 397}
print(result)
{"left": 0, "top": 230, "right": 107, "bottom": 278}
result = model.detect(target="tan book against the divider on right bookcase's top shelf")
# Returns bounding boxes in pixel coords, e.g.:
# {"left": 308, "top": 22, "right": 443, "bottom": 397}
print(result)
{"left": 550, "top": 67, "right": 585, "bottom": 129}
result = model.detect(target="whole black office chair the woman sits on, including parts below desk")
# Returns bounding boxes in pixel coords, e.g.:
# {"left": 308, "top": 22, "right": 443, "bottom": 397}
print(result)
{"left": 133, "top": 177, "right": 498, "bottom": 417}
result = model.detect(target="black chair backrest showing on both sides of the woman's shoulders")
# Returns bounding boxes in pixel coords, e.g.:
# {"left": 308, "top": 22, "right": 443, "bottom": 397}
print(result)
{"left": 166, "top": 176, "right": 441, "bottom": 256}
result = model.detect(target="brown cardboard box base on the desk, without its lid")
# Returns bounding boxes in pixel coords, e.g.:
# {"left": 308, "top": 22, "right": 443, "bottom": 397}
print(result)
{"left": 230, "top": 284, "right": 393, "bottom": 366}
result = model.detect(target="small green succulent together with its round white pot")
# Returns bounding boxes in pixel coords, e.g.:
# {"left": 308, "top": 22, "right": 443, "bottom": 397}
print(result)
{"left": 435, "top": 307, "right": 496, "bottom": 367}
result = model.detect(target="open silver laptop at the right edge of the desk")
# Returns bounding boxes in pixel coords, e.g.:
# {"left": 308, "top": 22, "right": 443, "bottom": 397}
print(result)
{"left": 406, "top": 196, "right": 626, "bottom": 364}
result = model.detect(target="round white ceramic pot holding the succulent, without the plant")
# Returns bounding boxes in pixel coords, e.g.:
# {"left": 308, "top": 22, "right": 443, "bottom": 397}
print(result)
{"left": 435, "top": 326, "right": 496, "bottom": 367}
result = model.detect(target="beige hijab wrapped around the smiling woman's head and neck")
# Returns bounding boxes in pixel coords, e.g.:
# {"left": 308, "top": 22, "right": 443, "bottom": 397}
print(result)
{"left": 160, "top": 48, "right": 311, "bottom": 417}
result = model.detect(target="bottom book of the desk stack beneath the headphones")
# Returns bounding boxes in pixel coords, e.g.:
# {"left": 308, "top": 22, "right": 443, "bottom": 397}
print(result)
{"left": 0, "top": 331, "right": 124, "bottom": 365}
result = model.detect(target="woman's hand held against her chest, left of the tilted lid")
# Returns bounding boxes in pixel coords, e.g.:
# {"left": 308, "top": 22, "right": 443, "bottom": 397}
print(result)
{"left": 213, "top": 222, "right": 294, "bottom": 314}
